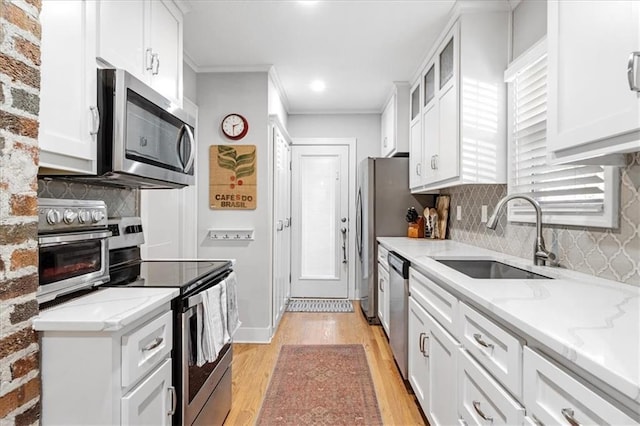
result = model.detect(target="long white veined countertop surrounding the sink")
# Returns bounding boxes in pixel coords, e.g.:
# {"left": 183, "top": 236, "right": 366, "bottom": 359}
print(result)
{"left": 378, "top": 237, "right": 640, "bottom": 409}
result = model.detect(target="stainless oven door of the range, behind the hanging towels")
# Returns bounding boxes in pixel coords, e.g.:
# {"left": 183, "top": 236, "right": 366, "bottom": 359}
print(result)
{"left": 181, "top": 294, "right": 233, "bottom": 426}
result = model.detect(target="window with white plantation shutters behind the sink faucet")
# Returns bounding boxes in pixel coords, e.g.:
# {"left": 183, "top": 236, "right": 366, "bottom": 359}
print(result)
{"left": 505, "top": 43, "right": 619, "bottom": 227}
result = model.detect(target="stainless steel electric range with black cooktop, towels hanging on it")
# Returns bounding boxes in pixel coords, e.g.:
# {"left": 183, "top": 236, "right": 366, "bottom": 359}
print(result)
{"left": 103, "top": 218, "right": 233, "bottom": 426}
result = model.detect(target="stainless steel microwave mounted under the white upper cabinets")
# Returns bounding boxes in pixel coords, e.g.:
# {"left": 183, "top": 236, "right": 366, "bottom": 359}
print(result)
{"left": 92, "top": 69, "right": 196, "bottom": 188}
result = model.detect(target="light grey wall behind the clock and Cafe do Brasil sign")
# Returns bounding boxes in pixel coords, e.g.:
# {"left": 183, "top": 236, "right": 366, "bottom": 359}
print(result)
{"left": 197, "top": 72, "right": 271, "bottom": 342}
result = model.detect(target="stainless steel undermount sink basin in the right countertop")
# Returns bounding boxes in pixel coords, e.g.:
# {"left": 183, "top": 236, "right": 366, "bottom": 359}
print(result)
{"left": 434, "top": 259, "right": 553, "bottom": 280}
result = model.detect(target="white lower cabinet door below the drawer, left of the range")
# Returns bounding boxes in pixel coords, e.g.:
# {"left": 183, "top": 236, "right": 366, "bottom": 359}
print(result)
{"left": 122, "top": 359, "right": 176, "bottom": 426}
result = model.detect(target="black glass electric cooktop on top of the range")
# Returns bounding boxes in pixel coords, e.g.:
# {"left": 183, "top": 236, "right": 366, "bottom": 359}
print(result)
{"left": 105, "top": 260, "right": 231, "bottom": 295}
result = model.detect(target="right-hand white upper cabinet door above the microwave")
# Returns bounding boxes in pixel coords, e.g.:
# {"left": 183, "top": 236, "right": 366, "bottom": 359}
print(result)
{"left": 145, "top": 1, "right": 182, "bottom": 105}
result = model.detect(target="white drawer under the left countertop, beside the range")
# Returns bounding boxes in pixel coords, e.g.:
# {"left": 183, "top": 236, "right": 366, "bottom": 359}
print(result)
{"left": 121, "top": 311, "right": 173, "bottom": 388}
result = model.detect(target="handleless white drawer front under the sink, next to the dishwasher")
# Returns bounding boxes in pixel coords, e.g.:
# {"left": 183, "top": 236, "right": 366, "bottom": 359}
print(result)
{"left": 409, "top": 268, "right": 458, "bottom": 336}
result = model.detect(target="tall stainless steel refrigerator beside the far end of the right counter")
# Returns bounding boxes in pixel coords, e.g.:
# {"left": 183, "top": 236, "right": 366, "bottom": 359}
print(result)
{"left": 356, "top": 157, "right": 434, "bottom": 324}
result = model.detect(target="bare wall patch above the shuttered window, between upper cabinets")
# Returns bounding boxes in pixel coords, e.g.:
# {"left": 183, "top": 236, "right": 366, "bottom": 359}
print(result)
{"left": 512, "top": 0, "right": 547, "bottom": 59}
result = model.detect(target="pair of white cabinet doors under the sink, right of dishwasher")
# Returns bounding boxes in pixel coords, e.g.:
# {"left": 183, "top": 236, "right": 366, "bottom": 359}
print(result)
{"left": 408, "top": 297, "right": 460, "bottom": 425}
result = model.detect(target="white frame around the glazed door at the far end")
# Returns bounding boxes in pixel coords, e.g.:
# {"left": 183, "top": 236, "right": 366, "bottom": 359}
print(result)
{"left": 292, "top": 138, "right": 358, "bottom": 300}
